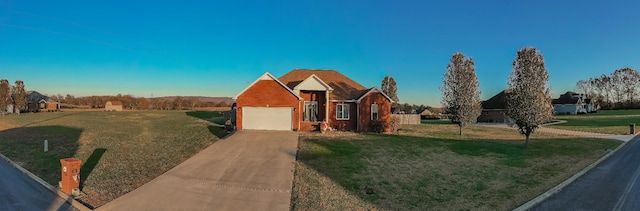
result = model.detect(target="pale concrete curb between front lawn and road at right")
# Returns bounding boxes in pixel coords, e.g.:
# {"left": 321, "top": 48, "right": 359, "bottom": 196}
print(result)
{"left": 513, "top": 136, "right": 637, "bottom": 211}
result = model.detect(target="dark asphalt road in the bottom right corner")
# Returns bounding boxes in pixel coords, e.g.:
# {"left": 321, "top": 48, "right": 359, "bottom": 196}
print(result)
{"left": 532, "top": 137, "right": 640, "bottom": 210}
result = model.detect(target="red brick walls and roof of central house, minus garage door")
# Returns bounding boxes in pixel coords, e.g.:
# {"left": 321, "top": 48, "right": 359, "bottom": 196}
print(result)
{"left": 236, "top": 70, "right": 391, "bottom": 132}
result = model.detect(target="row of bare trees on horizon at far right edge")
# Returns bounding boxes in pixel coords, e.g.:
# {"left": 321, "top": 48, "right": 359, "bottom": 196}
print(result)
{"left": 576, "top": 67, "right": 640, "bottom": 109}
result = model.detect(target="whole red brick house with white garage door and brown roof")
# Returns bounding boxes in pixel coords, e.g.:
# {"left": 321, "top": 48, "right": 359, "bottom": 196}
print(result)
{"left": 234, "top": 69, "right": 392, "bottom": 131}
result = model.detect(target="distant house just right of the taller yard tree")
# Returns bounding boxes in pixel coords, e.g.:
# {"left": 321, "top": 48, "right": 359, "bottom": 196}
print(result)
{"left": 551, "top": 92, "right": 597, "bottom": 115}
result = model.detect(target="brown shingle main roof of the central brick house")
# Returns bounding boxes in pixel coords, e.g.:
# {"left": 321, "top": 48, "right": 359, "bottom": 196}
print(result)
{"left": 278, "top": 69, "right": 369, "bottom": 100}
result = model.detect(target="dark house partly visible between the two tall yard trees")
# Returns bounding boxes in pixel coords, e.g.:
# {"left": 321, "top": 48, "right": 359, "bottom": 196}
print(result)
{"left": 477, "top": 90, "right": 510, "bottom": 123}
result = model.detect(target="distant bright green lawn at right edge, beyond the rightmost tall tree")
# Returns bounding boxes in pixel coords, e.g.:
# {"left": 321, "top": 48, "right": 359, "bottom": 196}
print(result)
{"left": 548, "top": 110, "right": 640, "bottom": 134}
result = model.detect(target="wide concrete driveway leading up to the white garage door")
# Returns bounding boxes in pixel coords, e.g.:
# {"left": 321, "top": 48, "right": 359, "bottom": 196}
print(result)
{"left": 98, "top": 131, "right": 298, "bottom": 210}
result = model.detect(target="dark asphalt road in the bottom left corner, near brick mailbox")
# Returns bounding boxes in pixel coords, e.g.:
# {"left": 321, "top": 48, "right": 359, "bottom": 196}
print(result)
{"left": 0, "top": 156, "right": 76, "bottom": 210}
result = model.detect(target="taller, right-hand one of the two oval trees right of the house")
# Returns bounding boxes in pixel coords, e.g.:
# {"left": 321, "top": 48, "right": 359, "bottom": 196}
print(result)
{"left": 507, "top": 47, "right": 553, "bottom": 147}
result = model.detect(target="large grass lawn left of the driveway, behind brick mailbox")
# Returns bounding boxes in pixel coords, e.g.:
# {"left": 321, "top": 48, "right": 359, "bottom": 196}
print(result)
{"left": 0, "top": 111, "right": 218, "bottom": 207}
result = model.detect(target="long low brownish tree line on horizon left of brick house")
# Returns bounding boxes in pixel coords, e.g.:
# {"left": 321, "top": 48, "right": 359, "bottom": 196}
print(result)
{"left": 49, "top": 94, "right": 231, "bottom": 110}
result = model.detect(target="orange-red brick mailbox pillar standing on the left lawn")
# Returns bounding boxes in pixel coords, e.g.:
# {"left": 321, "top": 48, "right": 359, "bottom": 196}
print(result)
{"left": 60, "top": 158, "right": 82, "bottom": 195}
